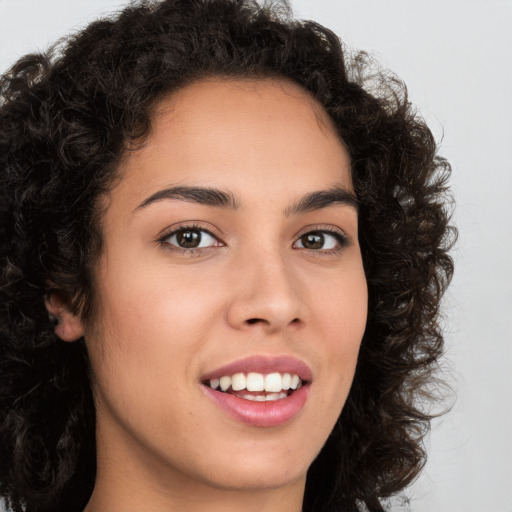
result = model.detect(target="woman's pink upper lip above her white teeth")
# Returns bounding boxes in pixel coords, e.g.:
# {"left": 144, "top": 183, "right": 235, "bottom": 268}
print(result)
{"left": 201, "top": 355, "right": 313, "bottom": 382}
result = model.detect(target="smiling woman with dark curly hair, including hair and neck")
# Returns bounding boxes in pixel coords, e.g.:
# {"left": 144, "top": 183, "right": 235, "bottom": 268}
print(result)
{"left": 0, "top": 0, "right": 452, "bottom": 512}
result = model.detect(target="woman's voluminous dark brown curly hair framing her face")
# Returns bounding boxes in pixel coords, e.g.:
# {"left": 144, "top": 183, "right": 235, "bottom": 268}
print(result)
{"left": 0, "top": 0, "right": 455, "bottom": 512}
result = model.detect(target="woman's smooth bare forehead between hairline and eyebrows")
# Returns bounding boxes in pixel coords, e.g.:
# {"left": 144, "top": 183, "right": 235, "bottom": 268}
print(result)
{"left": 111, "top": 79, "right": 351, "bottom": 208}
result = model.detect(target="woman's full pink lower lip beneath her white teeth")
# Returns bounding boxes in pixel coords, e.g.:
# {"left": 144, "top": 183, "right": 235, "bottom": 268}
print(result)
{"left": 201, "top": 384, "right": 310, "bottom": 427}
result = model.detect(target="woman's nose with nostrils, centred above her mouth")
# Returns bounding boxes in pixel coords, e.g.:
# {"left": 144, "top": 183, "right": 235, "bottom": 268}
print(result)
{"left": 227, "top": 249, "right": 307, "bottom": 334}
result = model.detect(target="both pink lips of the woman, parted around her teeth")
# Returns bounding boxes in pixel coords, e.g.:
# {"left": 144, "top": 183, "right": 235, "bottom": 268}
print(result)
{"left": 201, "top": 356, "right": 312, "bottom": 427}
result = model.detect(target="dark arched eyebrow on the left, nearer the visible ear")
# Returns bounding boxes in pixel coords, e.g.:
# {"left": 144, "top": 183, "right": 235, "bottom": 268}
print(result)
{"left": 133, "top": 187, "right": 240, "bottom": 213}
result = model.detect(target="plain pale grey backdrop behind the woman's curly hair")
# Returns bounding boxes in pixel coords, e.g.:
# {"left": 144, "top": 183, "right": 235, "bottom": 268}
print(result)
{"left": 0, "top": 0, "right": 512, "bottom": 512}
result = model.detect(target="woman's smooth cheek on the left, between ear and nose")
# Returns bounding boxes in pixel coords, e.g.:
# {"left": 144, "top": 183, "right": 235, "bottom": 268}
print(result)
{"left": 86, "top": 263, "right": 221, "bottom": 382}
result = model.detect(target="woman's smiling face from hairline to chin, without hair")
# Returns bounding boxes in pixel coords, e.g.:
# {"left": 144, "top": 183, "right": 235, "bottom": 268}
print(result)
{"left": 84, "top": 79, "right": 367, "bottom": 496}
